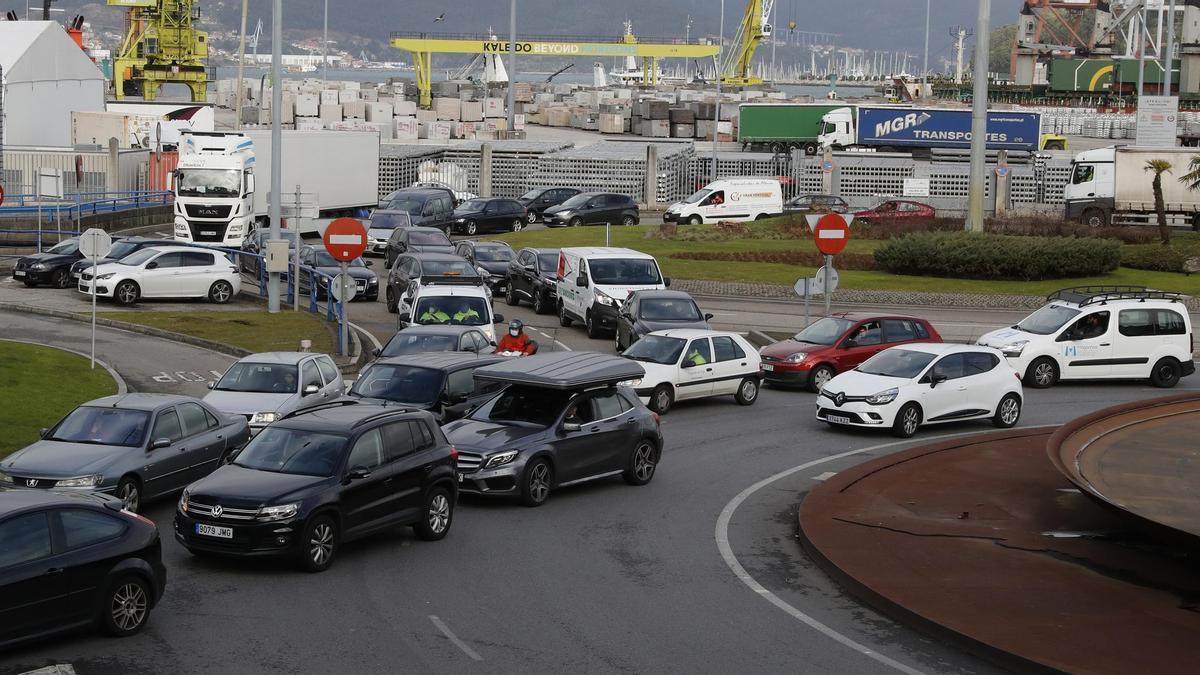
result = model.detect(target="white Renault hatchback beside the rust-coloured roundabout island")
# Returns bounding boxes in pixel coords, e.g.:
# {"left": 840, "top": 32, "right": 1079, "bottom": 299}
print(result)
{"left": 817, "top": 344, "right": 1025, "bottom": 438}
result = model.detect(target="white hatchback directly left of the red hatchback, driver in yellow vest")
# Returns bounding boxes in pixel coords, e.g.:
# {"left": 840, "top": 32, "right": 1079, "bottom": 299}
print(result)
{"left": 622, "top": 328, "right": 762, "bottom": 414}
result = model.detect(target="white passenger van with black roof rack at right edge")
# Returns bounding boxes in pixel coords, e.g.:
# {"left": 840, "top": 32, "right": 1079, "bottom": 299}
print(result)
{"left": 979, "top": 286, "right": 1195, "bottom": 389}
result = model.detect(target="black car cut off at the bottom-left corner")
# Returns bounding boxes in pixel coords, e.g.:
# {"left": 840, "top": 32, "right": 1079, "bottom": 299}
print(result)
{"left": 0, "top": 486, "right": 167, "bottom": 649}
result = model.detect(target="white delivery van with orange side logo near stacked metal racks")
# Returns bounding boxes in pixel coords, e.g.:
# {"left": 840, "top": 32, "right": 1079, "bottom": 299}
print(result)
{"left": 662, "top": 178, "right": 784, "bottom": 225}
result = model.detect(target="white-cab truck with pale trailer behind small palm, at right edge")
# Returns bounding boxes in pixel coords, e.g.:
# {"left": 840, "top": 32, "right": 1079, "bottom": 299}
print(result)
{"left": 1062, "top": 145, "right": 1200, "bottom": 227}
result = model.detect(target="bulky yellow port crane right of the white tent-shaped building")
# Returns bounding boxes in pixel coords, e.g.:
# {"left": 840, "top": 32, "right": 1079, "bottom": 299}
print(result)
{"left": 108, "top": 0, "right": 209, "bottom": 102}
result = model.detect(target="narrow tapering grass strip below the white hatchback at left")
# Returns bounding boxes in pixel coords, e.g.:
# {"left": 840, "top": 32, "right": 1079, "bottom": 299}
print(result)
{"left": 97, "top": 310, "right": 337, "bottom": 354}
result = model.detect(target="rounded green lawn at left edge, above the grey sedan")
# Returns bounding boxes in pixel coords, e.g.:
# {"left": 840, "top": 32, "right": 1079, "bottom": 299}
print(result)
{"left": 0, "top": 340, "right": 116, "bottom": 458}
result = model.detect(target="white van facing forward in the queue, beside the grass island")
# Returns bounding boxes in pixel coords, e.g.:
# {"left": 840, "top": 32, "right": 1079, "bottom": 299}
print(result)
{"left": 558, "top": 246, "right": 671, "bottom": 339}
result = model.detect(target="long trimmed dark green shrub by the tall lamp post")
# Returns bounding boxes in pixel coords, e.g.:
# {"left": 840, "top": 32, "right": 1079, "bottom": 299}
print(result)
{"left": 875, "top": 232, "right": 1121, "bottom": 281}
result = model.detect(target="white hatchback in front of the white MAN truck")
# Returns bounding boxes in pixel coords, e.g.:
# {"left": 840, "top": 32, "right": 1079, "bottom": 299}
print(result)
{"left": 79, "top": 246, "right": 241, "bottom": 305}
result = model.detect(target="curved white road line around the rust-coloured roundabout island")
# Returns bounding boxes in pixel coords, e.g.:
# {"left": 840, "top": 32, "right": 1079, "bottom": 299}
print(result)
{"left": 715, "top": 424, "right": 1057, "bottom": 675}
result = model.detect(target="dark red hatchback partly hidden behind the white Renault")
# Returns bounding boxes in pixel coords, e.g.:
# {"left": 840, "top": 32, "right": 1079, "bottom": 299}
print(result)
{"left": 758, "top": 312, "right": 942, "bottom": 392}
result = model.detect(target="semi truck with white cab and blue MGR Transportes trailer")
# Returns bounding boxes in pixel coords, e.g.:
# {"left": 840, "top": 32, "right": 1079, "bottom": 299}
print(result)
{"left": 817, "top": 106, "right": 1067, "bottom": 153}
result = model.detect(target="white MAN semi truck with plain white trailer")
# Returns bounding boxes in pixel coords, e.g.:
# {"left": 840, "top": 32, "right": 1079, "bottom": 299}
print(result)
{"left": 173, "top": 130, "right": 379, "bottom": 247}
